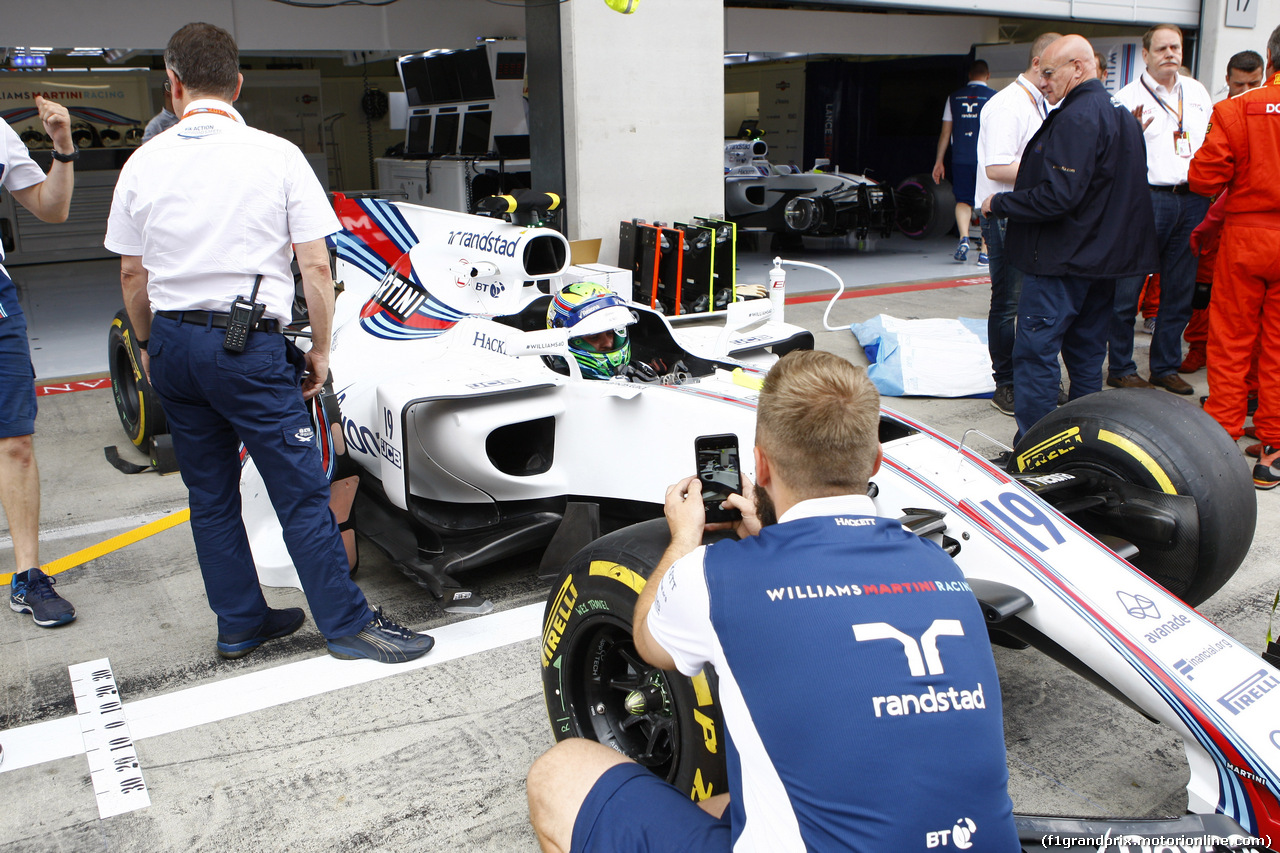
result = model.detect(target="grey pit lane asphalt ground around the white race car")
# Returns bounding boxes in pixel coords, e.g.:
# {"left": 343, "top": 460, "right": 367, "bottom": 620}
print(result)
{"left": 0, "top": 266, "right": 1280, "bottom": 853}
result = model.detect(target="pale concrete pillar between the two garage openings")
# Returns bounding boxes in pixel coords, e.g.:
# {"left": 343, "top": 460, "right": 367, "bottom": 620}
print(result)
{"left": 561, "top": 0, "right": 724, "bottom": 263}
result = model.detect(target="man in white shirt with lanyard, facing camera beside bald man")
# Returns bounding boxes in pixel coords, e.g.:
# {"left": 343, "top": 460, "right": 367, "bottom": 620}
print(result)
{"left": 1107, "top": 24, "right": 1213, "bottom": 394}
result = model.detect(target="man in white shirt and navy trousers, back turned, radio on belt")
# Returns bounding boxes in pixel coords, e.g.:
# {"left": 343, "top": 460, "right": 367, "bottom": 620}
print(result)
{"left": 106, "top": 23, "right": 433, "bottom": 663}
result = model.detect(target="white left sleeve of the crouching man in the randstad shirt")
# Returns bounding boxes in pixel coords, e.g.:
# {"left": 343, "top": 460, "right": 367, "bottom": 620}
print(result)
{"left": 648, "top": 546, "right": 717, "bottom": 676}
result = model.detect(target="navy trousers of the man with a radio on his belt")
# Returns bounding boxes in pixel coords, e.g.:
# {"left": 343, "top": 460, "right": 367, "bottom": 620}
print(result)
{"left": 148, "top": 316, "right": 371, "bottom": 639}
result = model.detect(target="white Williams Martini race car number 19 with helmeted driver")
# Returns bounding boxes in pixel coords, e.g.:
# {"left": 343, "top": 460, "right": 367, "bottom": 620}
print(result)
{"left": 110, "top": 193, "right": 1280, "bottom": 838}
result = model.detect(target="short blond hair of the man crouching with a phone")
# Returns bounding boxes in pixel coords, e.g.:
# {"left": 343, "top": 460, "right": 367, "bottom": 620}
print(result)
{"left": 755, "top": 350, "right": 879, "bottom": 500}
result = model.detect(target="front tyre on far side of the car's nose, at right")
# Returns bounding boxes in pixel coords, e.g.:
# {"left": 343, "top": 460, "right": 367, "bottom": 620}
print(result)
{"left": 1010, "top": 388, "right": 1257, "bottom": 607}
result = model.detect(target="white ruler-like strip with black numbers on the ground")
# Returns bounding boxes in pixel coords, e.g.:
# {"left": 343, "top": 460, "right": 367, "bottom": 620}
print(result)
{"left": 67, "top": 657, "right": 151, "bottom": 818}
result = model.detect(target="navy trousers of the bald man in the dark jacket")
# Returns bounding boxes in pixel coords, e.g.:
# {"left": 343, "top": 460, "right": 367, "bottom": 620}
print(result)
{"left": 1014, "top": 273, "right": 1115, "bottom": 442}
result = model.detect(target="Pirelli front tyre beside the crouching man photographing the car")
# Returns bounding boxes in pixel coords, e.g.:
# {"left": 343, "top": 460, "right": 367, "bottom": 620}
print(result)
{"left": 541, "top": 519, "right": 728, "bottom": 802}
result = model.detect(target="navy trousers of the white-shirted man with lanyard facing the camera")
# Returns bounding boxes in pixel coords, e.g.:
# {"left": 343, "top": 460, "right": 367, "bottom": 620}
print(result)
{"left": 1107, "top": 190, "right": 1208, "bottom": 378}
